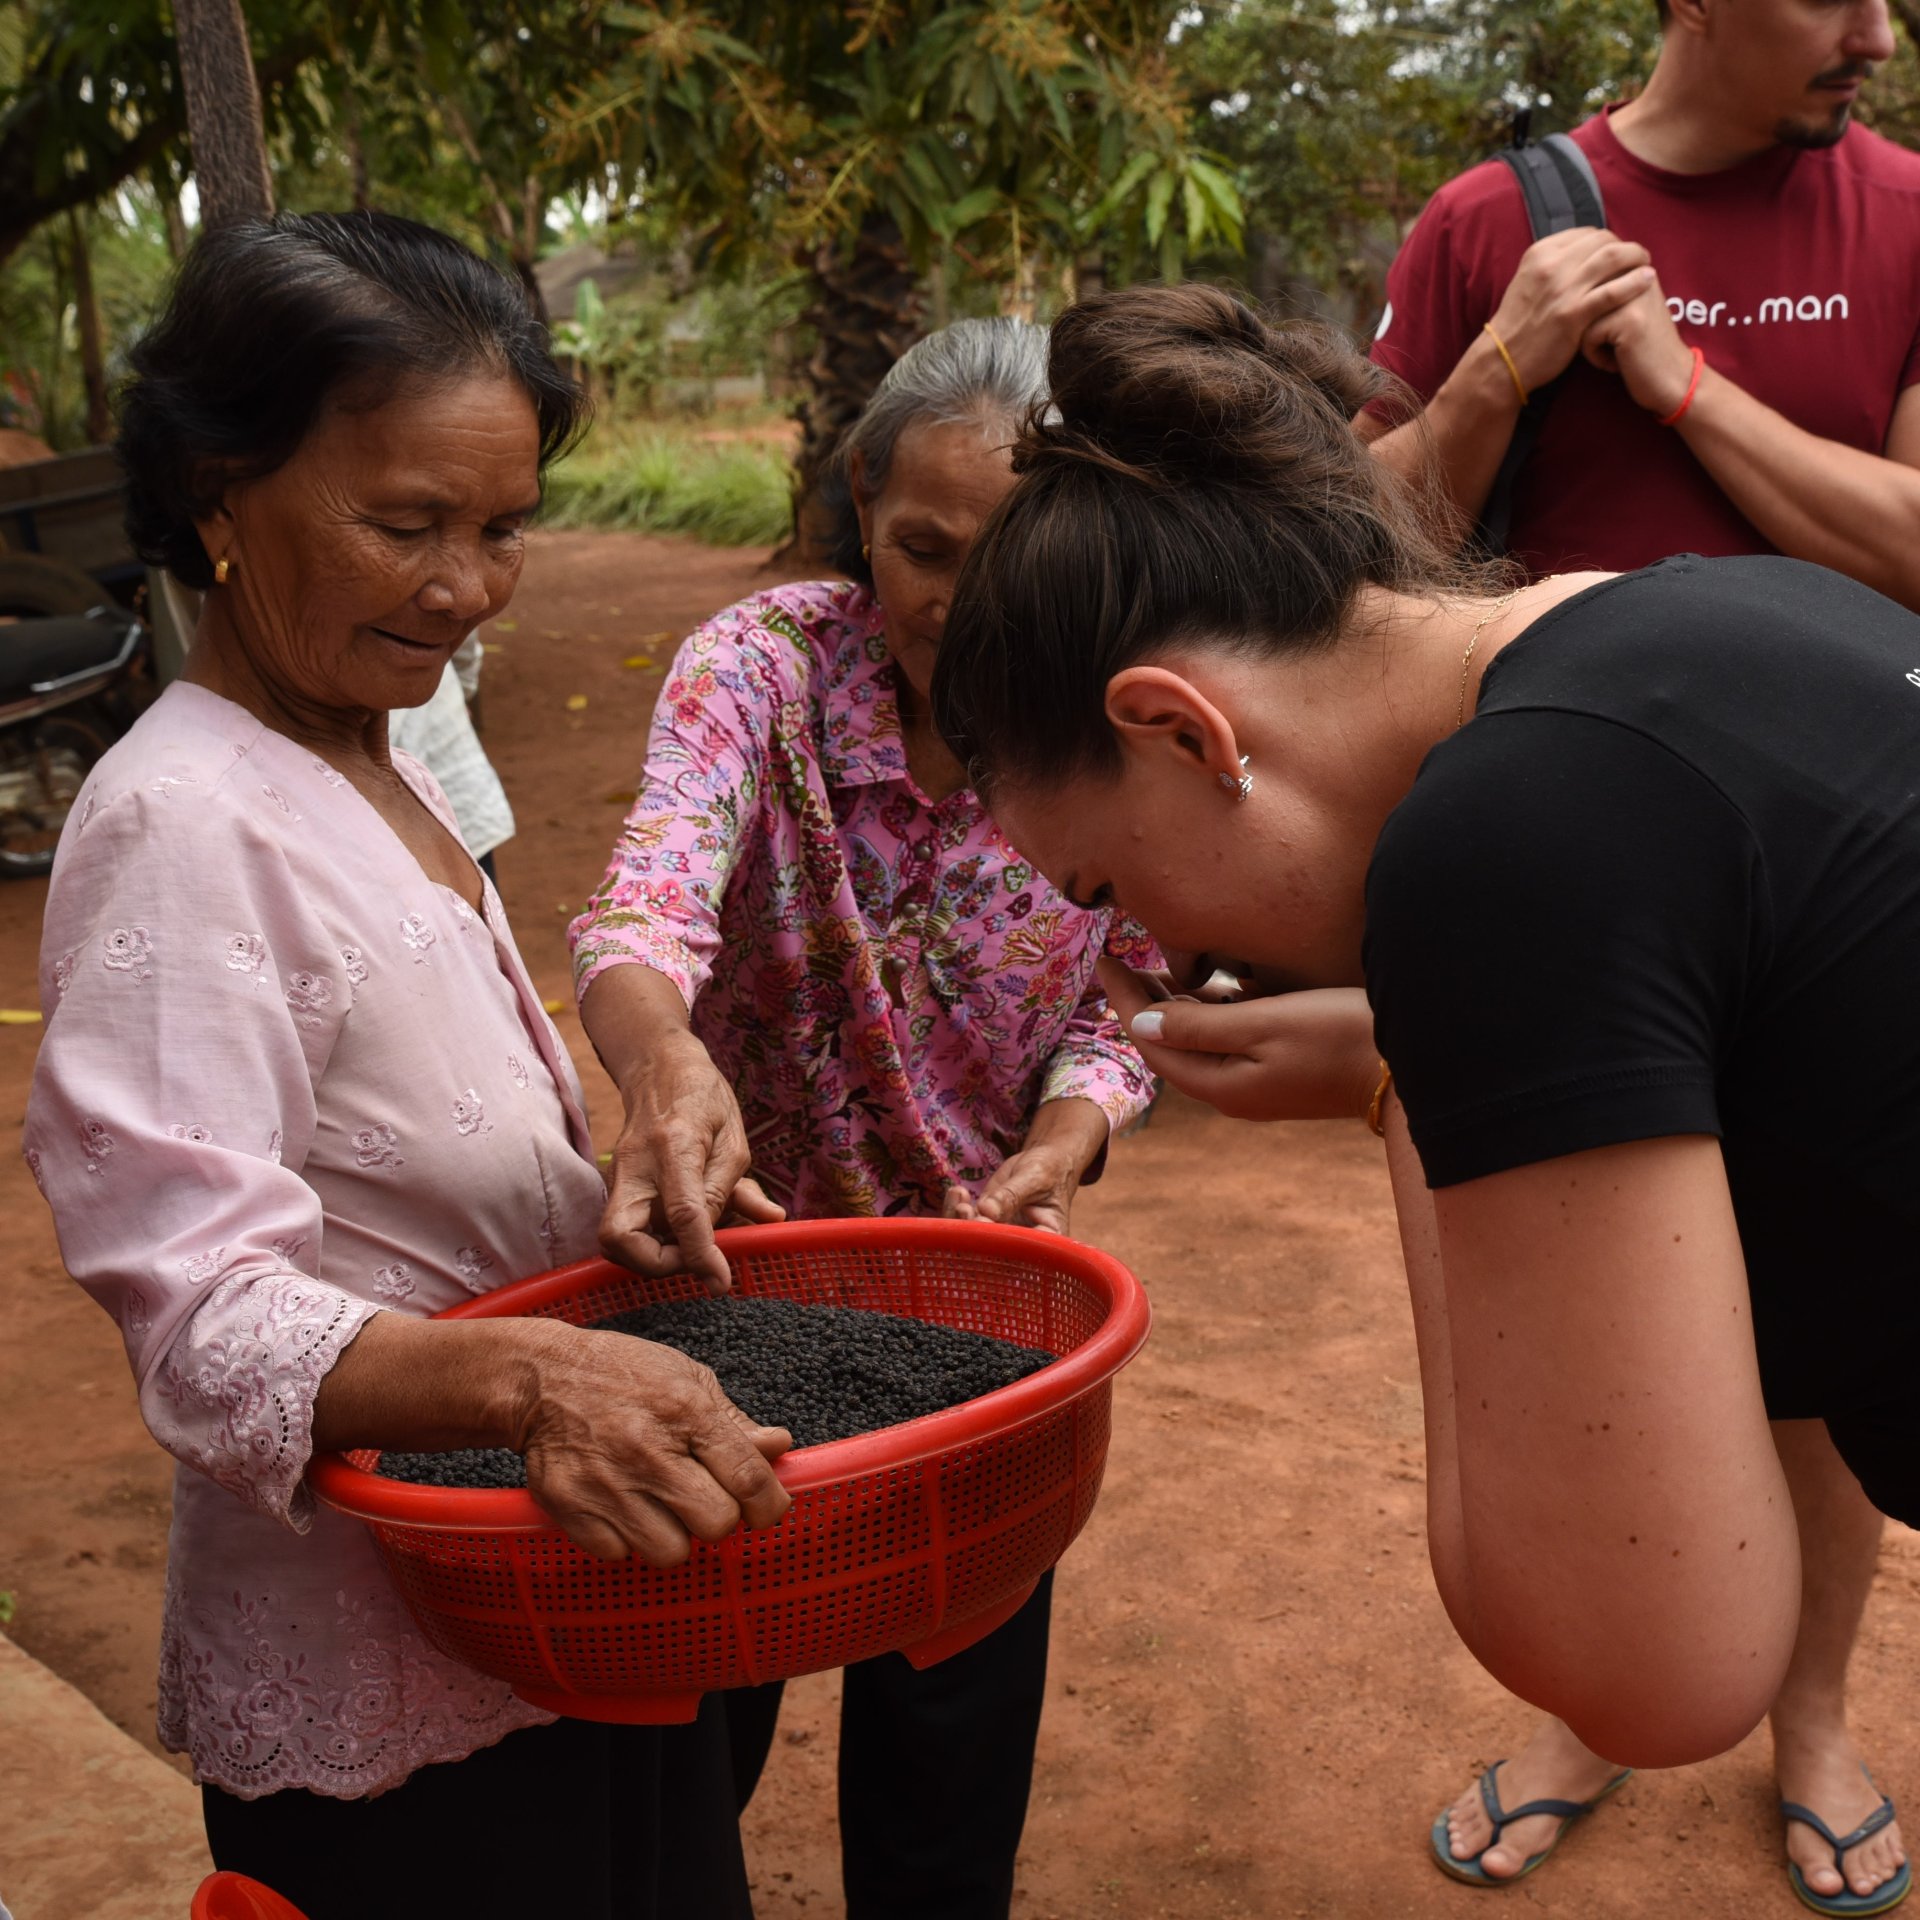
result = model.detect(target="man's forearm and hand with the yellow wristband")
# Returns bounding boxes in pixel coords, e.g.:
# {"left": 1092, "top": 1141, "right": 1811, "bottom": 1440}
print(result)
{"left": 1356, "top": 227, "right": 1653, "bottom": 526}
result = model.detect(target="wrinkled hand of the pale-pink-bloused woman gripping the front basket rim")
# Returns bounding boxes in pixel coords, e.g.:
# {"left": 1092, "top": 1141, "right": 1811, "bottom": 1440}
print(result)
{"left": 513, "top": 1323, "right": 793, "bottom": 1567}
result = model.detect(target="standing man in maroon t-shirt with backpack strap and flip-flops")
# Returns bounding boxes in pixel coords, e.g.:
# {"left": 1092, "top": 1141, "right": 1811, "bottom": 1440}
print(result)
{"left": 1359, "top": 0, "right": 1920, "bottom": 1912}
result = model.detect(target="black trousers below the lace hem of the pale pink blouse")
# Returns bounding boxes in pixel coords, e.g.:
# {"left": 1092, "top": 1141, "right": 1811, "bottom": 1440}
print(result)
{"left": 202, "top": 1695, "right": 753, "bottom": 1920}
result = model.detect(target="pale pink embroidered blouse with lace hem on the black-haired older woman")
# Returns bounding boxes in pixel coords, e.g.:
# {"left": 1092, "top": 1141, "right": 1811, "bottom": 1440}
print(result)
{"left": 25, "top": 684, "right": 605, "bottom": 1797}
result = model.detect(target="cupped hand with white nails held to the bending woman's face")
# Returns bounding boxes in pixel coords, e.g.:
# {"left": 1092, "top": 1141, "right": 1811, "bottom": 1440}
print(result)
{"left": 1100, "top": 960, "right": 1380, "bottom": 1119}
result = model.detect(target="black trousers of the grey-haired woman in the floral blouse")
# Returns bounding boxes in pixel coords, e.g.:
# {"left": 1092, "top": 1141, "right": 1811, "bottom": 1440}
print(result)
{"left": 724, "top": 1572, "right": 1054, "bottom": 1920}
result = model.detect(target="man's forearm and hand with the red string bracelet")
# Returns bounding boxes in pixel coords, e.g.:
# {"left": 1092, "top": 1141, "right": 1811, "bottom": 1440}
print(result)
{"left": 1586, "top": 284, "right": 1920, "bottom": 611}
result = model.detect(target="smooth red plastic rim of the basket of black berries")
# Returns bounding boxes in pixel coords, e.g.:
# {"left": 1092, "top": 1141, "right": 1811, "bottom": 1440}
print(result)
{"left": 307, "top": 1217, "right": 1152, "bottom": 1536}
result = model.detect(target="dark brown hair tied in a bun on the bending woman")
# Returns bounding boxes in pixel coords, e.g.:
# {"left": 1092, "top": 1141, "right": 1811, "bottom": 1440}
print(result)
{"left": 931, "top": 286, "right": 1488, "bottom": 795}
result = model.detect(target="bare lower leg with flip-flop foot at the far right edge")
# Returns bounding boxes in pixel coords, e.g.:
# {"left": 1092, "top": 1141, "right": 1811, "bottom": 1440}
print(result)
{"left": 1768, "top": 1421, "right": 1907, "bottom": 1893}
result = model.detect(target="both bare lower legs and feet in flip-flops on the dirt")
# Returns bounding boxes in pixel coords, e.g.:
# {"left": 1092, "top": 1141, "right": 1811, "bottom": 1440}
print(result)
{"left": 1448, "top": 1421, "right": 1907, "bottom": 1893}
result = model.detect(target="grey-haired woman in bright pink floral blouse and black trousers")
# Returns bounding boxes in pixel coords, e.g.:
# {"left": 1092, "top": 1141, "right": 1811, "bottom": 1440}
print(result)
{"left": 572, "top": 321, "right": 1150, "bottom": 1920}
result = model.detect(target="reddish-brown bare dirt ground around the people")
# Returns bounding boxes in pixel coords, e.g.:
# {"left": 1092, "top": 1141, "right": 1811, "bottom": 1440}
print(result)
{"left": 0, "top": 534, "right": 1920, "bottom": 1920}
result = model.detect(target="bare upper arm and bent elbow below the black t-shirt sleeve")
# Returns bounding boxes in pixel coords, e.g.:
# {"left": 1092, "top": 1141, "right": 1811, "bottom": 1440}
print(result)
{"left": 1394, "top": 1119, "right": 1799, "bottom": 1766}
